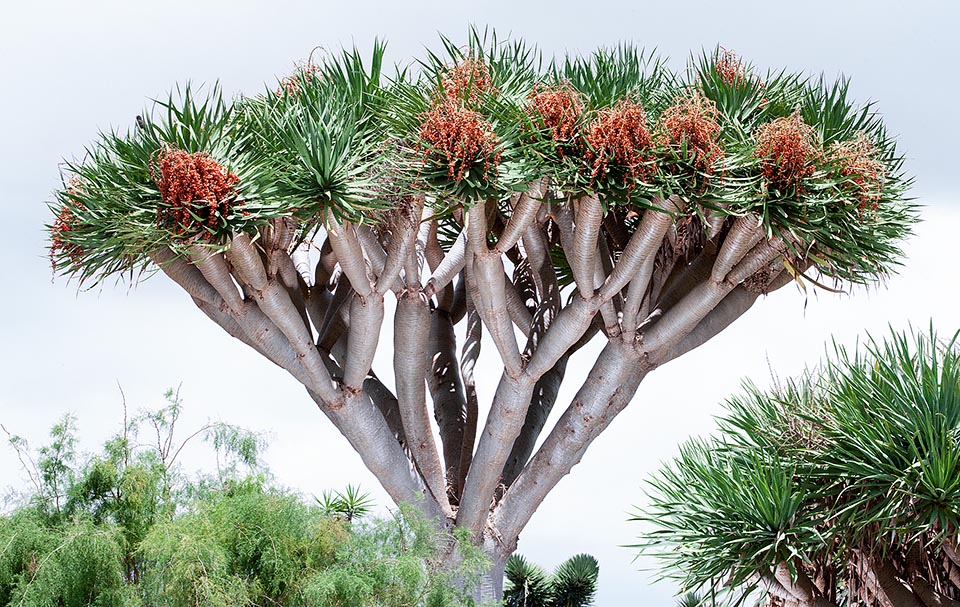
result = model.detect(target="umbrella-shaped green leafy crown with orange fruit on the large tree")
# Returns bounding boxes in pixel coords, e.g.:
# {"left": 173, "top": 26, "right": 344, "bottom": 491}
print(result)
{"left": 48, "top": 30, "right": 915, "bottom": 282}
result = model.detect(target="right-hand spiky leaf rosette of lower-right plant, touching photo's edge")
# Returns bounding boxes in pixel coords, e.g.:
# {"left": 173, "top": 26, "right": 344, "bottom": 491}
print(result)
{"left": 820, "top": 329, "right": 960, "bottom": 580}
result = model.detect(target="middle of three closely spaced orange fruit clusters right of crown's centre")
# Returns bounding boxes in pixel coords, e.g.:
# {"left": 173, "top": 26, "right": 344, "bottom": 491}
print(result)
{"left": 586, "top": 98, "right": 656, "bottom": 188}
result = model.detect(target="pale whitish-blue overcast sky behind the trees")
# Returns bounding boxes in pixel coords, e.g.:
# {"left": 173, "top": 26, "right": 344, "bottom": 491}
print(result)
{"left": 0, "top": 0, "right": 960, "bottom": 607}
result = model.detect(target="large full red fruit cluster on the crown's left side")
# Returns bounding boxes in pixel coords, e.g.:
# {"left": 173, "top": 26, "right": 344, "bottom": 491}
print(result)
{"left": 150, "top": 148, "right": 240, "bottom": 237}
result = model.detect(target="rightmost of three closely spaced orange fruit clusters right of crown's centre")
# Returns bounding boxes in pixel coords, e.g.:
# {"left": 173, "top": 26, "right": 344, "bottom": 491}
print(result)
{"left": 658, "top": 92, "right": 724, "bottom": 172}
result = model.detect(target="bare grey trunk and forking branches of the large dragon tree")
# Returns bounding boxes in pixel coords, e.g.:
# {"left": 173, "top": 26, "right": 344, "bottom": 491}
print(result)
{"left": 154, "top": 197, "right": 796, "bottom": 601}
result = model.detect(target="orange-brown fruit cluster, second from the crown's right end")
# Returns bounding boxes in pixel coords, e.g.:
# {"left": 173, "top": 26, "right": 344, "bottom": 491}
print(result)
{"left": 753, "top": 112, "right": 817, "bottom": 193}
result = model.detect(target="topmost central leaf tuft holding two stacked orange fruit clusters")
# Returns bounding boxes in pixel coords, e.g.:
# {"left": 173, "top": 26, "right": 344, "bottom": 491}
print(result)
{"left": 386, "top": 29, "right": 543, "bottom": 211}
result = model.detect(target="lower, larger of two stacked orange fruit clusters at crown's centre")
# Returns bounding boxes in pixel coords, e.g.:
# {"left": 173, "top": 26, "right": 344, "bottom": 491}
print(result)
{"left": 420, "top": 100, "right": 500, "bottom": 181}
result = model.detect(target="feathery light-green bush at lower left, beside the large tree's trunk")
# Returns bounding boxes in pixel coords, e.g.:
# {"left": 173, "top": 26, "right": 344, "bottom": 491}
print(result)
{"left": 0, "top": 393, "right": 487, "bottom": 607}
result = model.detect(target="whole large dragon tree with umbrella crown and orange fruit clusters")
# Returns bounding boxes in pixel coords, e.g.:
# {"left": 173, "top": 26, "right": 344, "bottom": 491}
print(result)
{"left": 49, "top": 32, "right": 916, "bottom": 596}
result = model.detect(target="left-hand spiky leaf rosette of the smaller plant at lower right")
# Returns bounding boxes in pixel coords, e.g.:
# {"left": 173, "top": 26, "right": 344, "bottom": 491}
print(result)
{"left": 641, "top": 440, "right": 822, "bottom": 591}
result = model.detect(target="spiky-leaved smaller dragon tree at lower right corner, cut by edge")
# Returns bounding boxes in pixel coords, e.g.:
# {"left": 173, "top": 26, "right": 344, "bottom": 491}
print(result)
{"left": 638, "top": 330, "right": 960, "bottom": 607}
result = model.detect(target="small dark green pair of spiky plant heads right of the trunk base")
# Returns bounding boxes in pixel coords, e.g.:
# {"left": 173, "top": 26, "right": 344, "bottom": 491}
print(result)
{"left": 503, "top": 554, "right": 600, "bottom": 607}
